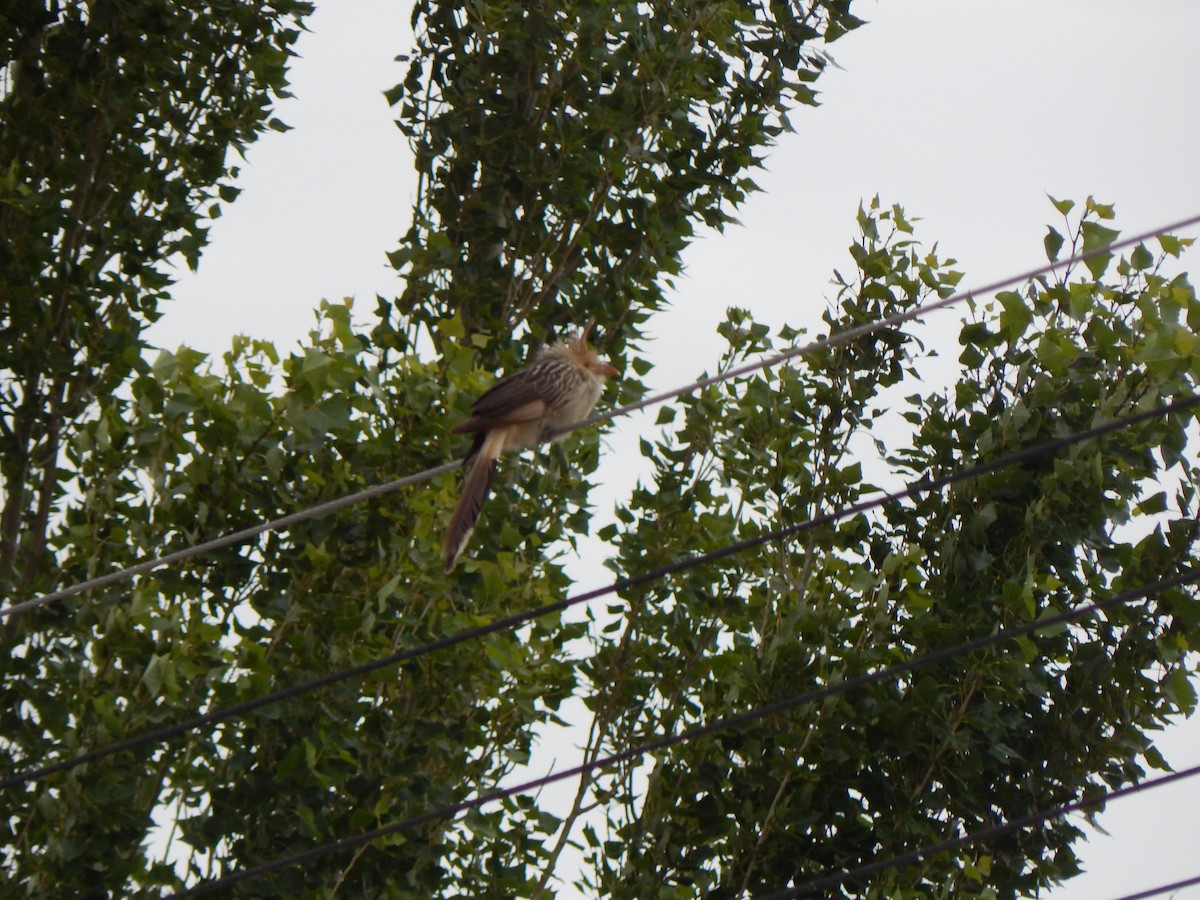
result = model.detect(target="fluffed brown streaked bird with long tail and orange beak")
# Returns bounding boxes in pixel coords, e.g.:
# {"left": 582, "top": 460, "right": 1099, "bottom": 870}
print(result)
{"left": 442, "top": 323, "right": 617, "bottom": 572}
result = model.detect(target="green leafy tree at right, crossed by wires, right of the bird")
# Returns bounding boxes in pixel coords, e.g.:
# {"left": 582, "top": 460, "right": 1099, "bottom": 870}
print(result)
{"left": 573, "top": 202, "right": 1200, "bottom": 898}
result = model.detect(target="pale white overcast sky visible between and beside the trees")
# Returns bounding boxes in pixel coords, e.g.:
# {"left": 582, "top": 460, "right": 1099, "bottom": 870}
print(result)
{"left": 150, "top": 0, "right": 1200, "bottom": 900}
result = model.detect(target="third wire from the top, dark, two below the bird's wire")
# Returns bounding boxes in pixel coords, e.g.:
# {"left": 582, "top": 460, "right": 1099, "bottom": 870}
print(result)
{"left": 168, "top": 569, "right": 1200, "bottom": 900}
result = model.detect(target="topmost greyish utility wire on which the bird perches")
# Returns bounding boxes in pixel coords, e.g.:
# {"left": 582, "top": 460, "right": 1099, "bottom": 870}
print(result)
{"left": 0, "top": 215, "right": 1200, "bottom": 619}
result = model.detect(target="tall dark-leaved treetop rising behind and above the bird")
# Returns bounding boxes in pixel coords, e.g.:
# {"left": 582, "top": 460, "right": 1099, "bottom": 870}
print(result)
{"left": 382, "top": 0, "right": 858, "bottom": 364}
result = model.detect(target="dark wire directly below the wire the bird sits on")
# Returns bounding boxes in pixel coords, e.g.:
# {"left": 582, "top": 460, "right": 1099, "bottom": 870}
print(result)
{"left": 0, "top": 395, "right": 1200, "bottom": 790}
